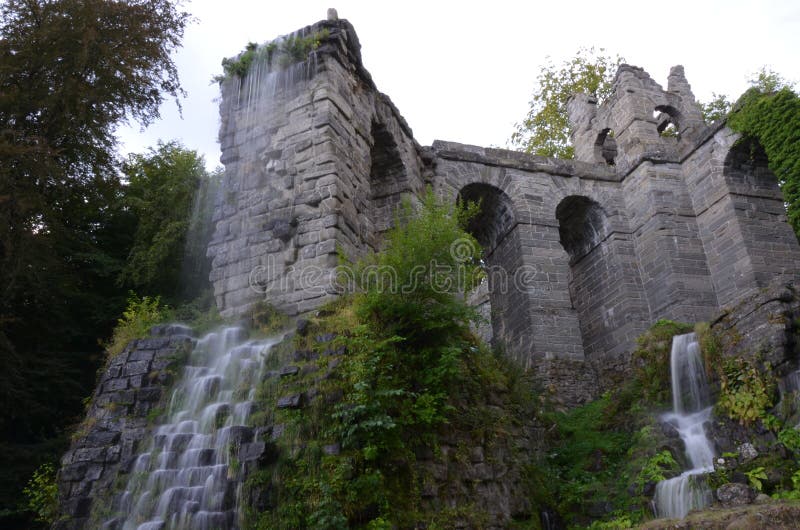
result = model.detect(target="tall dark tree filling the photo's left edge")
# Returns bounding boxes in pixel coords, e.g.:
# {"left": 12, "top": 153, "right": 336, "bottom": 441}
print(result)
{"left": 0, "top": 0, "right": 189, "bottom": 527}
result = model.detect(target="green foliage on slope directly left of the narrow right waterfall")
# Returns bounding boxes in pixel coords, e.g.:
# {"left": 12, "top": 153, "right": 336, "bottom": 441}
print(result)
{"left": 544, "top": 320, "right": 692, "bottom": 528}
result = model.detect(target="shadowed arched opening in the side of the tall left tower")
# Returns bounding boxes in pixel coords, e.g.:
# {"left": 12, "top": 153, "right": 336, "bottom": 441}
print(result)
{"left": 365, "top": 122, "right": 409, "bottom": 241}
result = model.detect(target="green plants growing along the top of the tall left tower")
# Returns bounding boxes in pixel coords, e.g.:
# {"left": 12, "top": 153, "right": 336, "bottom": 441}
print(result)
{"left": 214, "top": 29, "right": 330, "bottom": 83}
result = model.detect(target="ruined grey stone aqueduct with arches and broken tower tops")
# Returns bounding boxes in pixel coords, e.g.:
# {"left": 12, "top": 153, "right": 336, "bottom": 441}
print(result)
{"left": 209, "top": 20, "right": 800, "bottom": 402}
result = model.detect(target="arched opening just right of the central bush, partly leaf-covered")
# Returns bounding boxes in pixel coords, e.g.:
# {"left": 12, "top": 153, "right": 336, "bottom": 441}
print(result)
{"left": 458, "top": 183, "right": 525, "bottom": 344}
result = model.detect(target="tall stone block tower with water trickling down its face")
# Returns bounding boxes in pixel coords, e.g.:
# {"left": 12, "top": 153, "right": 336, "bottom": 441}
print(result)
{"left": 208, "top": 21, "right": 423, "bottom": 316}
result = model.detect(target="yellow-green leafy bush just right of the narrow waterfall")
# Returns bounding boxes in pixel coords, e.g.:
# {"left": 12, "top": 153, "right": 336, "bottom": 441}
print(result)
{"left": 717, "top": 357, "right": 775, "bottom": 425}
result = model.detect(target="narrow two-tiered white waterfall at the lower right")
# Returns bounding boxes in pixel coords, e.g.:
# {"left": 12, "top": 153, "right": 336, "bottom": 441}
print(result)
{"left": 654, "top": 333, "right": 714, "bottom": 518}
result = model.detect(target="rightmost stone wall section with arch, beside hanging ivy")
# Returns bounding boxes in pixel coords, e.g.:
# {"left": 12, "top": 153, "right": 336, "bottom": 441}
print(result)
{"left": 683, "top": 128, "right": 800, "bottom": 308}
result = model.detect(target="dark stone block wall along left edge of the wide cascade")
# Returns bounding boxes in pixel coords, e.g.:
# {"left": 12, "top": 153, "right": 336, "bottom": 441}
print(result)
{"left": 54, "top": 326, "right": 193, "bottom": 530}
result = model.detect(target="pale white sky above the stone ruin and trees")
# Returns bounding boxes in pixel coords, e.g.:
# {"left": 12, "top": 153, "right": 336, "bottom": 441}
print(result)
{"left": 119, "top": 0, "right": 800, "bottom": 168}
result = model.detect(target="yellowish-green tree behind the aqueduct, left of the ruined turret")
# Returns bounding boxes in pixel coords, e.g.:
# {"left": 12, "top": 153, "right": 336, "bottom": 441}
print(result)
{"left": 511, "top": 48, "right": 624, "bottom": 158}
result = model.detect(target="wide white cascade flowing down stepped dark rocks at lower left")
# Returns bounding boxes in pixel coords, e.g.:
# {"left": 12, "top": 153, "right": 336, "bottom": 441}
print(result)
{"left": 108, "top": 327, "right": 279, "bottom": 530}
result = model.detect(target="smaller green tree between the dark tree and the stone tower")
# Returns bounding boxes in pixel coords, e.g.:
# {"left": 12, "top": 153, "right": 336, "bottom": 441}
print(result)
{"left": 119, "top": 142, "right": 218, "bottom": 302}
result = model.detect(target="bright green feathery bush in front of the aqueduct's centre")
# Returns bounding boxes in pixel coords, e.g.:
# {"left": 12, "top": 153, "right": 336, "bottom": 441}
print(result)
{"left": 352, "top": 190, "right": 483, "bottom": 342}
